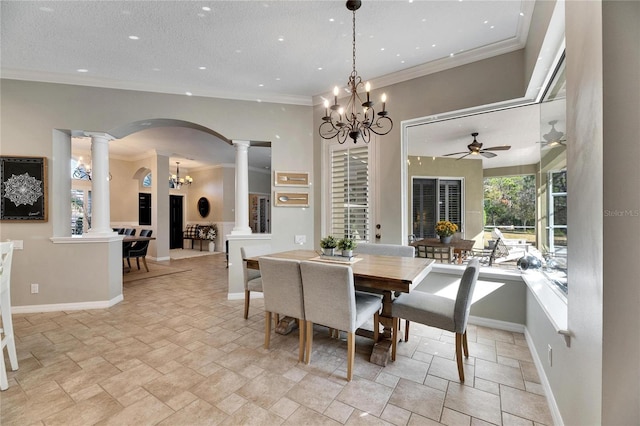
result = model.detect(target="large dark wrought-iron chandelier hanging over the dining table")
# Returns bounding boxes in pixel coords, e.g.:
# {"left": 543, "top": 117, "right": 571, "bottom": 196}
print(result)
{"left": 319, "top": 0, "right": 393, "bottom": 144}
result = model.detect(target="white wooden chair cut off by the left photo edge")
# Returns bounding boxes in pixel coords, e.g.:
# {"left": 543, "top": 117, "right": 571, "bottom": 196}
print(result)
{"left": 0, "top": 241, "right": 18, "bottom": 390}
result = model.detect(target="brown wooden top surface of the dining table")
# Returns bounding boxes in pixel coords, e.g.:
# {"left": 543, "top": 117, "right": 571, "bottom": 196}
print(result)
{"left": 245, "top": 250, "right": 434, "bottom": 293}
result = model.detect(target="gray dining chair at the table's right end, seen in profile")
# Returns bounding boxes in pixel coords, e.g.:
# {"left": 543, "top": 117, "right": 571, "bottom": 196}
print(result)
{"left": 391, "top": 259, "right": 480, "bottom": 382}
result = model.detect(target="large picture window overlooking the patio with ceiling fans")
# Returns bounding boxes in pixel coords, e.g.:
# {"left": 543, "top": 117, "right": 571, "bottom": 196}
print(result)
{"left": 405, "top": 53, "right": 568, "bottom": 292}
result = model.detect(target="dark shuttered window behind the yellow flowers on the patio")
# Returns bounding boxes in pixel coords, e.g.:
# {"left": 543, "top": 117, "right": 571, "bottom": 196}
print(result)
{"left": 412, "top": 178, "right": 463, "bottom": 238}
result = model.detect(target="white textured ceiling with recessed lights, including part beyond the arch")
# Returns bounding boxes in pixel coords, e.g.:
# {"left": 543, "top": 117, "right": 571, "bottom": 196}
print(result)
{"left": 0, "top": 0, "right": 534, "bottom": 168}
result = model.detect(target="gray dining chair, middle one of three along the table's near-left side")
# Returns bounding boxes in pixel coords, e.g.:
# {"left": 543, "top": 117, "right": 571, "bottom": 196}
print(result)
{"left": 259, "top": 257, "right": 305, "bottom": 362}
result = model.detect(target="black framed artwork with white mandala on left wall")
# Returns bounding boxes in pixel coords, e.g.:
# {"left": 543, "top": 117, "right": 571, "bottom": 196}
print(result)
{"left": 0, "top": 156, "right": 47, "bottom": 222}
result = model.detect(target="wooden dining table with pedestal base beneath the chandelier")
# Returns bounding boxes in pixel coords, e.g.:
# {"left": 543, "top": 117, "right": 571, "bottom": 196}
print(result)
{"left": 244, "top": 250, "right": 434, "bottom": 366}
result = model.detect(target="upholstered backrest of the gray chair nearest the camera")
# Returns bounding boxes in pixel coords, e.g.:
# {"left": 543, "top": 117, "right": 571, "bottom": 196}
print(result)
{"left": 300, "top": 261, "right": 356, "bottom": 333}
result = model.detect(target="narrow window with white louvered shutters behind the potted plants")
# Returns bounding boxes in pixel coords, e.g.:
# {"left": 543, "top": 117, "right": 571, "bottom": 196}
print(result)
{"left": 329, "top": 145, "right": 373, "bottom": 242}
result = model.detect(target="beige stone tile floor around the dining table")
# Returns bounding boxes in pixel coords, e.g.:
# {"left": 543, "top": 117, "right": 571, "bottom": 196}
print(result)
{"left": 0, "top": 256, "right": 552, "bottom": 426}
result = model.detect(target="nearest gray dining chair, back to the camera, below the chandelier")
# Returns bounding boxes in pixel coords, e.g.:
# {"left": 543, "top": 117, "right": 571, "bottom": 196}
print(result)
{"left": 300, "top": 261, "right": 382, "bottom": 381}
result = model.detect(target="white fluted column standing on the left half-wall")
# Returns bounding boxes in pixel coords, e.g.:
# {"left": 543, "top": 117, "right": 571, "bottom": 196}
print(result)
{"left": 85, "top": 132, "right": 115, "bottom": 236}
